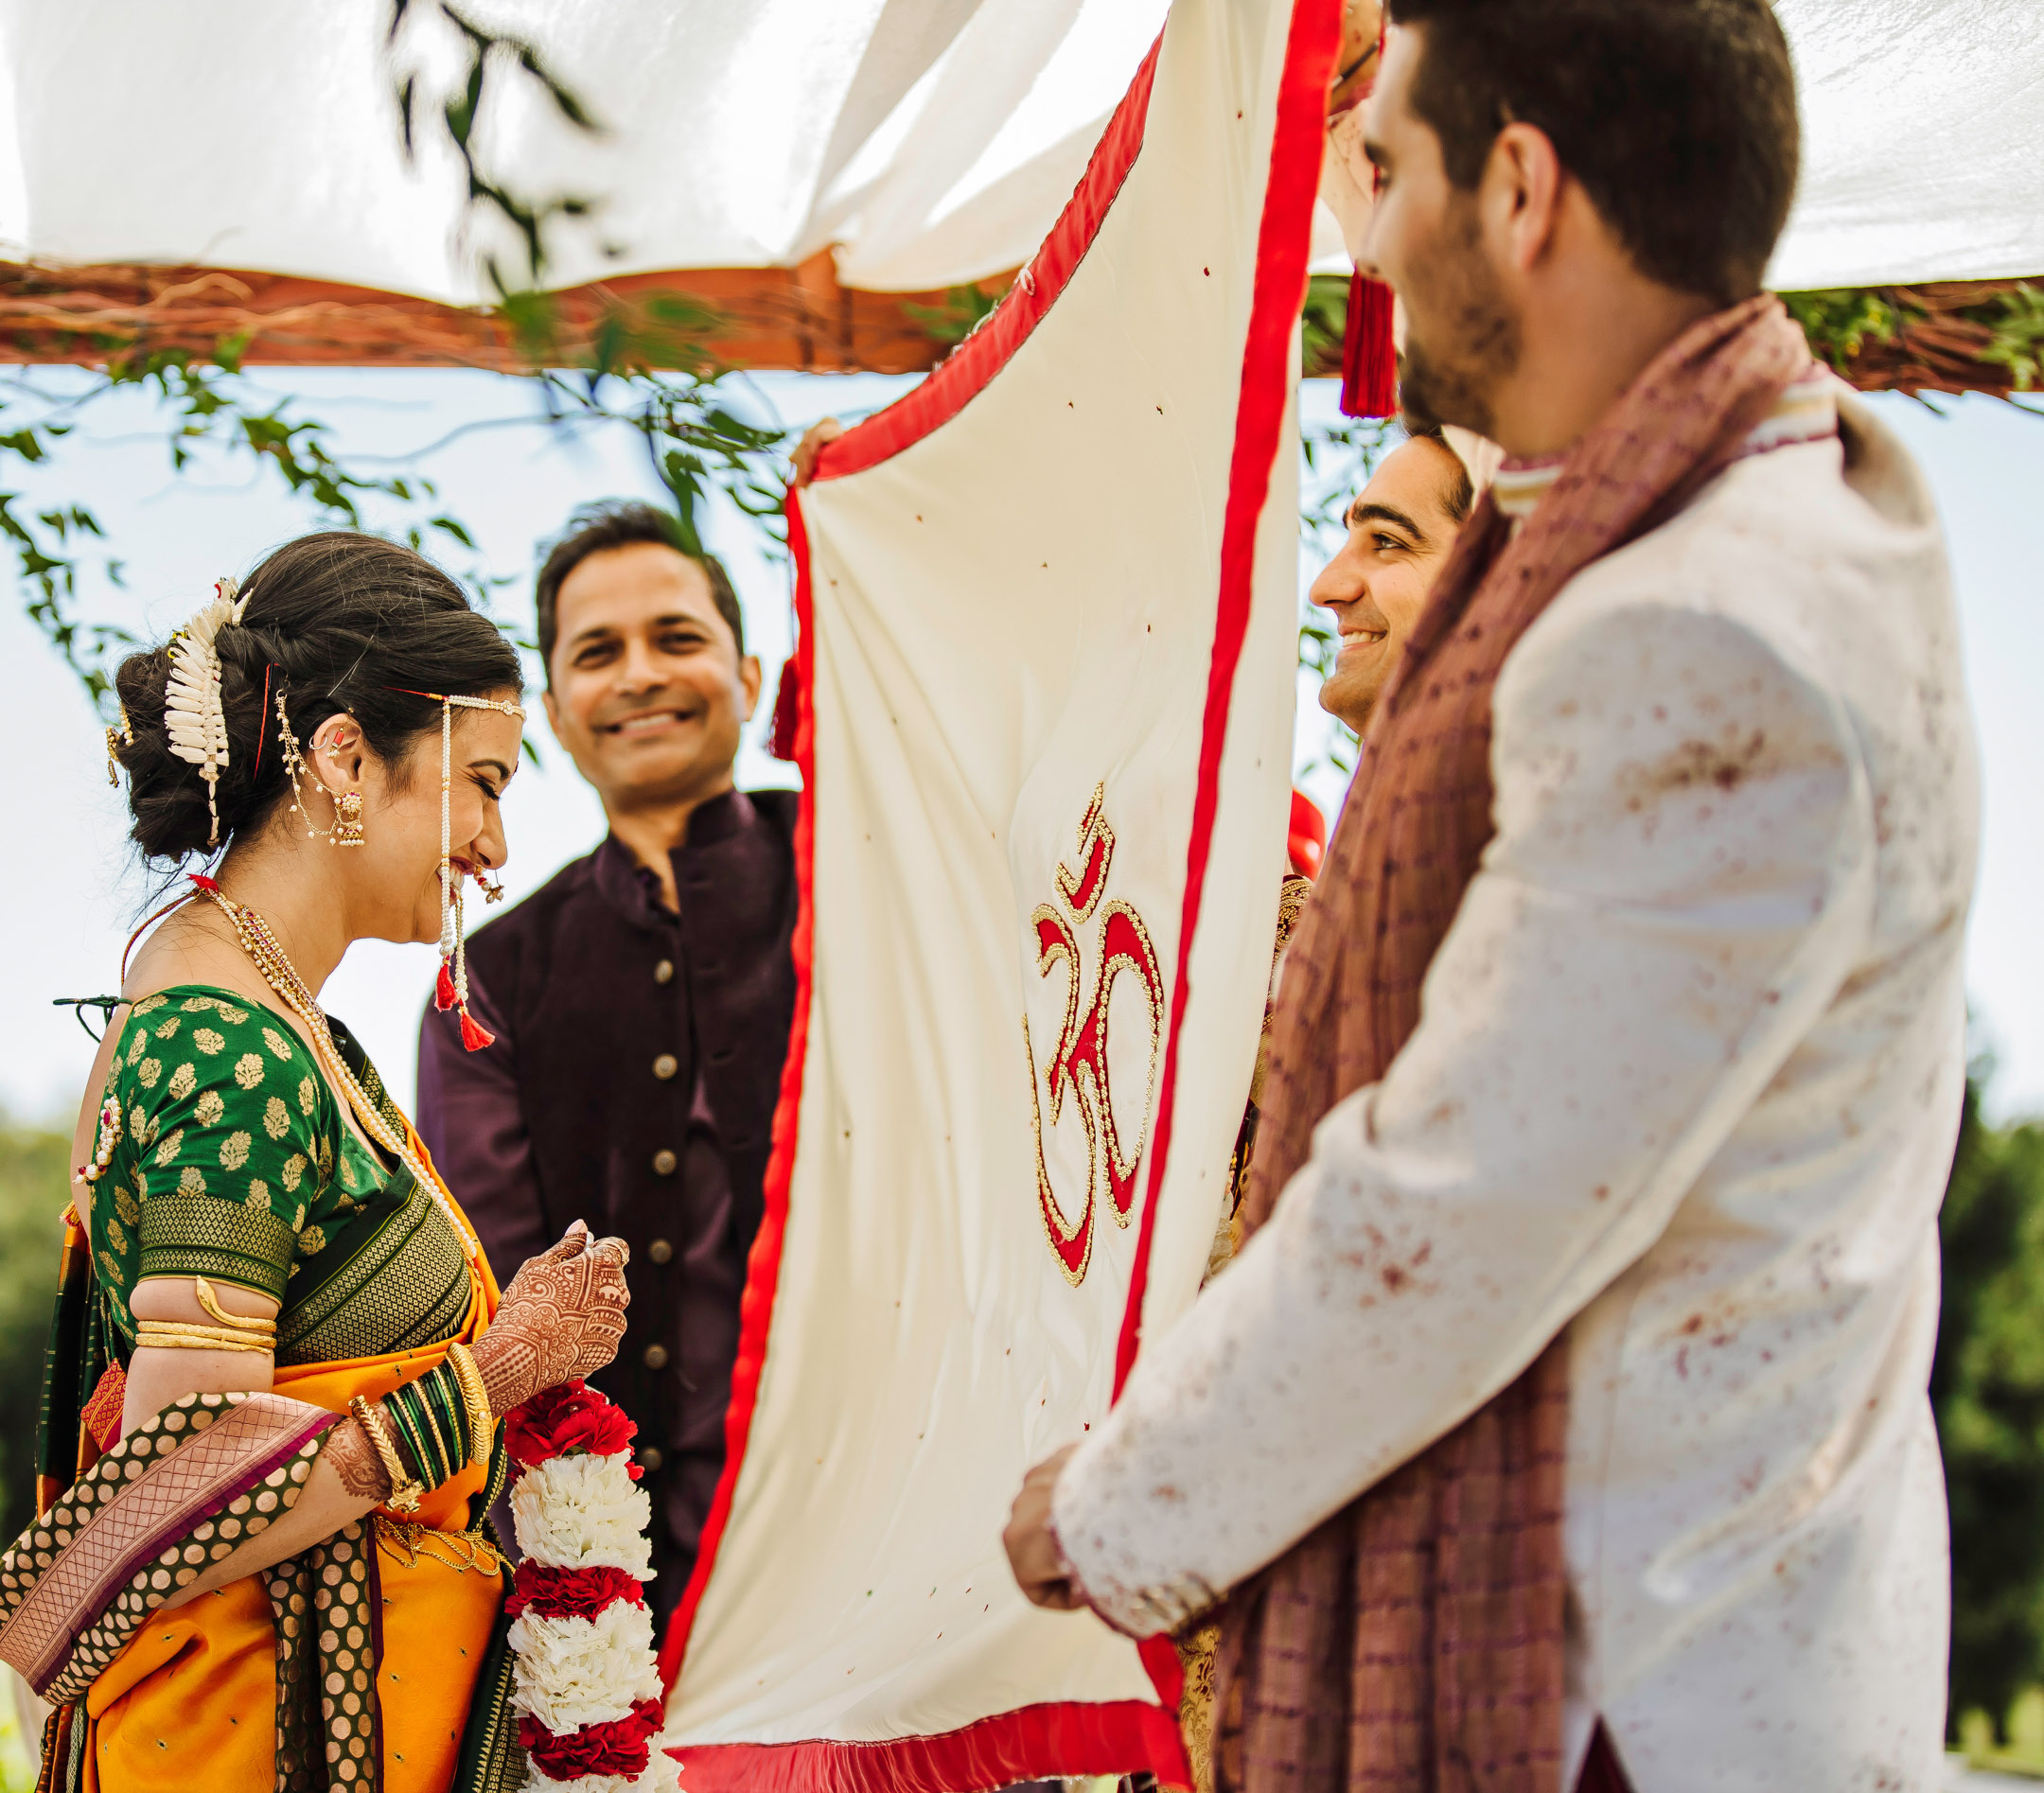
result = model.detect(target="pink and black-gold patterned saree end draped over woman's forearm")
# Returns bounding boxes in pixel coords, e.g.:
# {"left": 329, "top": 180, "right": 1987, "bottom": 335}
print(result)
{"left": 0, "top": 1395, "right": 333, "bottom": 1705}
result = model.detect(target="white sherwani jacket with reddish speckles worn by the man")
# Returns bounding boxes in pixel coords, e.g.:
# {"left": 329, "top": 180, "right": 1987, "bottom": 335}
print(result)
{"left": 1055, "top": 389, "right": 1977, "bottom": 1793}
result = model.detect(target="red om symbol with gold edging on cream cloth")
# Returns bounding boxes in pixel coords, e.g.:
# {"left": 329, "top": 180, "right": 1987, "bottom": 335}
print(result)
{"left": 1022, "top": 785, "right": 1163, "bottom": 1288}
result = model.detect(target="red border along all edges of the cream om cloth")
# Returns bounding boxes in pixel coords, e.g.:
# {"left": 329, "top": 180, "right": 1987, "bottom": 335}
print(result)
{"left": 661, "top": 0, "right": 1341, "bottom": 1793}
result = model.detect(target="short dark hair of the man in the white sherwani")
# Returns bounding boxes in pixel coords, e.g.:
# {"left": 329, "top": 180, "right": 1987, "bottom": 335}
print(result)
{"left": 1392, "top": 0, "right": 1801, "bottom": 305}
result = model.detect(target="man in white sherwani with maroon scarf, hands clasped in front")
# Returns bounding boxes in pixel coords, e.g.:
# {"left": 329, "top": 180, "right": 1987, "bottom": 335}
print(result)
{"left": 1008, "top": 0, "right": 1977, "bottom": 1793}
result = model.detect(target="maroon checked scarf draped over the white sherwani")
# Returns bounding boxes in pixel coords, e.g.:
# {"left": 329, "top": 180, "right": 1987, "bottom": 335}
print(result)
{"left": 1214, "top": 296, "right": 1809, "bottom": 1793}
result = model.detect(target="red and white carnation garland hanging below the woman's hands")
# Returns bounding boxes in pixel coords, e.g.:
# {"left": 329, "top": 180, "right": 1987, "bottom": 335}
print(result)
{"left": 505, "top": 1382, "right": 680, "bottom": 1793}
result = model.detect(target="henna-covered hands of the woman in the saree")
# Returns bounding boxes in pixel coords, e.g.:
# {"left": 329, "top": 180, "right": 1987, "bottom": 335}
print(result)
{"left": 474, "top": 1221, "right": 631, "bottom": 1416}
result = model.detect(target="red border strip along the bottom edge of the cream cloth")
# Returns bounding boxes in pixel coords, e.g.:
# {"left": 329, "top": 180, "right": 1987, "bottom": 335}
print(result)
{"left": 668, "top": 1699, "right": 1191, "bottom": 1793}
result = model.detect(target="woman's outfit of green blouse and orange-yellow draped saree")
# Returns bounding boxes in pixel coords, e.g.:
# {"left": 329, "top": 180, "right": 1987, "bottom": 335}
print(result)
{"left": 18, "top": 985, "right": 523, "bottom": 1793}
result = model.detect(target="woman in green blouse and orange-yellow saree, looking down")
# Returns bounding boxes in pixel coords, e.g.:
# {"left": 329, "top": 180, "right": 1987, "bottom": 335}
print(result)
{"left": 0, "top": 532, "right": 627, "bottom": 1793}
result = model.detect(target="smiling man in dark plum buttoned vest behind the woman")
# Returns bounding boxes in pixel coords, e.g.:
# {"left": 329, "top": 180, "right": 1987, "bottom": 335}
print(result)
{"left": 419, "top": 503, "right": 795, "bottom": 1621}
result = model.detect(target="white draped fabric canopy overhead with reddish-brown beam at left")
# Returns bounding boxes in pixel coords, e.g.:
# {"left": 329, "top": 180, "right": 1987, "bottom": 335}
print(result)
{"left": 0, "top": 0, "right": 2044, "bottom": 384}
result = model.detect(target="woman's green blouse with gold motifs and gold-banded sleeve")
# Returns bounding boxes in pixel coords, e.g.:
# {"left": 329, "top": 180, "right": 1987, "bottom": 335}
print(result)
{"left": 92, "top": 983, "right": 468, "bottom": 1362}
